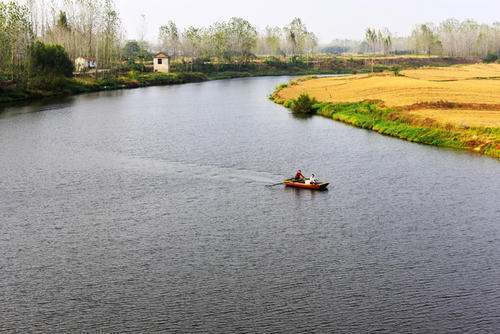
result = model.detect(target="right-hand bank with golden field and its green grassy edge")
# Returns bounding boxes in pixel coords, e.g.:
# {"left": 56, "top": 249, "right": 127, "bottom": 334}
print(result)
{"left": 271, "top": 64, "right": 500, "bottom": 159}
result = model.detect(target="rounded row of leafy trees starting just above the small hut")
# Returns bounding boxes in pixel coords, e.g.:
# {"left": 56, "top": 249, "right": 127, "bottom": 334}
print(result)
{"left": 159, "top": 17, "right": 318, "bottom": 61}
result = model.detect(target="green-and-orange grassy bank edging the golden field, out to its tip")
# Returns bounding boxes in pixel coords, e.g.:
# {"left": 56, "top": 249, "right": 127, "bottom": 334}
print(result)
{"left": 271, "top": 74, "right": 500, "bottom": 159}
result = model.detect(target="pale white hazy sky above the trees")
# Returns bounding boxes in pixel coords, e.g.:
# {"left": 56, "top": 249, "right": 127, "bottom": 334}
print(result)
{"left": 116, "top": 0, "right": 500, "bottom": 43}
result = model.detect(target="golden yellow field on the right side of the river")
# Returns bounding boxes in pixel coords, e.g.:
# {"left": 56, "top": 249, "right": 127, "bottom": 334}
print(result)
{"left": 278, "top": 64, "right": 500, "bottom": 127}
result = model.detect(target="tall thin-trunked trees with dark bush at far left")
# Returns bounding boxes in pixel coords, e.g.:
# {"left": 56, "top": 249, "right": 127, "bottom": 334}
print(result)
{"left": 0, "top": 0, "right": 123, "bottom": 86}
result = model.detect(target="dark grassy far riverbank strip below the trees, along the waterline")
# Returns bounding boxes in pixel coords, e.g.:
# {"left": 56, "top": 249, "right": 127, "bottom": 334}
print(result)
{"left": 0, "top": 56, "right": 474, "bottom": 105}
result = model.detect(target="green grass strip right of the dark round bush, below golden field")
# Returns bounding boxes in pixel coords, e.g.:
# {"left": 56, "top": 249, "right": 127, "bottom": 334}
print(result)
{"left": 271, "top": 92, "right": 500, "bottom": 159}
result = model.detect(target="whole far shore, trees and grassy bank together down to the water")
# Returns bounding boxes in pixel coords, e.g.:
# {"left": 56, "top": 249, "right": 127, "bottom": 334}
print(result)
{"left": 0, "top": 0, "right": 499, "bottom": 104}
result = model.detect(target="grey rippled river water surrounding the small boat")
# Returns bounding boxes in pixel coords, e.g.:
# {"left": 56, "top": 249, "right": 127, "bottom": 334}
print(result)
{"left": 0, "top": 77, "right": 500, "bottom": 333}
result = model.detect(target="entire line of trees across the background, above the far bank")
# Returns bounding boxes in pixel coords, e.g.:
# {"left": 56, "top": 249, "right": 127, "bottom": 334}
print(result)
{"left": 0, "top": 0, "right": 500, "bottom": 88}
